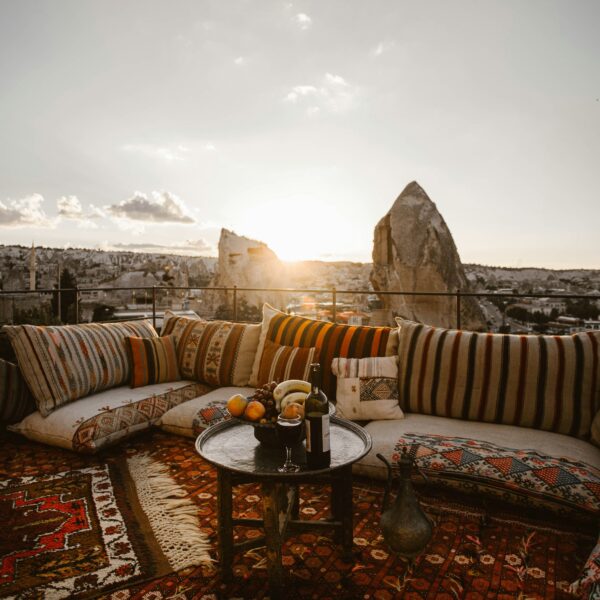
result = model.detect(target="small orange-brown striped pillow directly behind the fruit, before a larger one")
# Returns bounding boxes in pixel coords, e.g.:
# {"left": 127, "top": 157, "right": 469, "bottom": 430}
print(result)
{"left": 256, "top": 340, "right": 319, "bottom": 387}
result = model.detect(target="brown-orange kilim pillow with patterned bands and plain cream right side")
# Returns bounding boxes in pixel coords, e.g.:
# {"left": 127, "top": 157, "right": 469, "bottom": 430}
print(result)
{"left": 161, "top": 316, "right": 260, "bottom": 387}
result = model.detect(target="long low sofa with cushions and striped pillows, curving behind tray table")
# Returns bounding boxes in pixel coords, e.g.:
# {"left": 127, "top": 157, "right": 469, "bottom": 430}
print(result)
{"left": 0, "top": 305, "right": 600, "bottom": 597}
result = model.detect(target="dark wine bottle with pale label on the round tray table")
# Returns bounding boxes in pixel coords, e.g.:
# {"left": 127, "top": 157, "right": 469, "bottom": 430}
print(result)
{"left": 304, "top": 363, "right": 331, "bottom": 469}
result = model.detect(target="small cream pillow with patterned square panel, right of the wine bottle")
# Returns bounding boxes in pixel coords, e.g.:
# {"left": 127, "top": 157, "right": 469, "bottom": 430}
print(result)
{"left": 331, "top": 356, "right": 404, "bottom": 421}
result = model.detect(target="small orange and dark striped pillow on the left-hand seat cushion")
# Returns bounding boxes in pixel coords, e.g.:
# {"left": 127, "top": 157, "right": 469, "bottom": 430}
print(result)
{"left": 126, "top": 335, "right": 181, "bottom": 388}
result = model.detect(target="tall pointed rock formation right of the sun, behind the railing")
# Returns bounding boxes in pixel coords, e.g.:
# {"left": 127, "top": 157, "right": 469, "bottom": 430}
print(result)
{"left": 371, "top": 181, "right": 484, "bottom": 329}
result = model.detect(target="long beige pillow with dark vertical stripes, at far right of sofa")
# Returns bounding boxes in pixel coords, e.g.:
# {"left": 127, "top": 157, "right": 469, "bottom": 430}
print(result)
{"left": 398, "top": 320, "right": 600, "bottom": 438}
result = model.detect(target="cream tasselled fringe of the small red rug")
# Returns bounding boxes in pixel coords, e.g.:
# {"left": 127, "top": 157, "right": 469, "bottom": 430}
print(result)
{"left": 127, "top": 454, "right": 212, "bottom": 570}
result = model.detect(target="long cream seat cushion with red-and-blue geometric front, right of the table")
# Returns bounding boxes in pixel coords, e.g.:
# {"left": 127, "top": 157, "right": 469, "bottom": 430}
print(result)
{"left": 355, "top": 413, "right": 600, "bottom": 515}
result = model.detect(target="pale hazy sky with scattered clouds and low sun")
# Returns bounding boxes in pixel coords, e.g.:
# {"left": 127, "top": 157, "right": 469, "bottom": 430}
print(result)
{"left": 0, "top": 0, "right": 600, "bottom": 268}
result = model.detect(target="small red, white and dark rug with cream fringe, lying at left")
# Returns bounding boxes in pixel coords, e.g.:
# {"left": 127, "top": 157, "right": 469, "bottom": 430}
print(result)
{"left": 0, "top": 454, "right": 209, "bottom": 598}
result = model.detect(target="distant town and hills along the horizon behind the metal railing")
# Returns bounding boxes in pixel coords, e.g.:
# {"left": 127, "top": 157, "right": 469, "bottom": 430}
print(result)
{"left": 0, "top": 245, "right": 600, "bottom": 333}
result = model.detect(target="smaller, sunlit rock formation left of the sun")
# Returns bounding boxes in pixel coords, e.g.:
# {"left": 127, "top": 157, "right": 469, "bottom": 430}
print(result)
{"left": 207, "top": 229, "right": 287, "bottom": 310}
